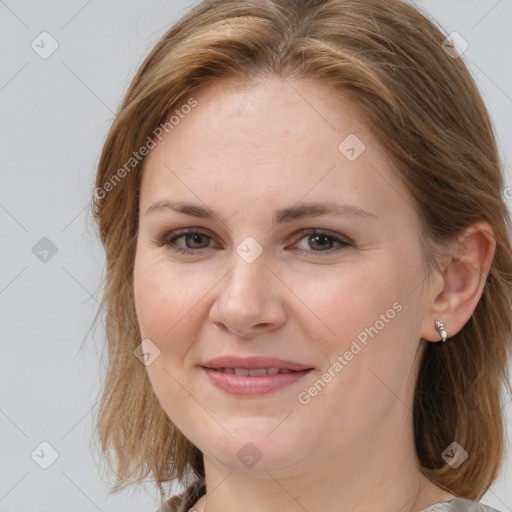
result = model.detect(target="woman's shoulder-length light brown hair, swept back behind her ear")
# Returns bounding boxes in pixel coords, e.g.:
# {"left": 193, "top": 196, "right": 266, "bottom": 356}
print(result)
{"left": 93, "top": 0, "right": 512, "bottom": 500}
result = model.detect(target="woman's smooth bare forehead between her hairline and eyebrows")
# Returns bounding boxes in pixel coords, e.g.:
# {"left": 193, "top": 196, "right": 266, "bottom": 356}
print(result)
{"left": 141, "top": 77, "right": 408, "bottom": 222}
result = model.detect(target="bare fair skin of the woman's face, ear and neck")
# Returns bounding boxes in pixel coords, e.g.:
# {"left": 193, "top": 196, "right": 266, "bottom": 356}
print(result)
{"left": 134, "top": 77, "right": 494, "bottom": 512}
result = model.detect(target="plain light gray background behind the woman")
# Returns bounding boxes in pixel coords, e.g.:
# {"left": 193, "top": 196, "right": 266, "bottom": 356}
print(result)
{"left": 0, "top": 0, "right": 512, "bottom": 512}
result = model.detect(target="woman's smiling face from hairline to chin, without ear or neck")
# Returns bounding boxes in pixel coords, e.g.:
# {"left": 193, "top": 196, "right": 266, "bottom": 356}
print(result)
{"left": 134, "top": 78, "right": 432, "bottom": 471}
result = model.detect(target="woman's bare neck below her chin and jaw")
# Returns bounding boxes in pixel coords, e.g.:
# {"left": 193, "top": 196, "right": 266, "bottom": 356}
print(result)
{"left": 190, "top": 401, "right": 454, "bottom": 512}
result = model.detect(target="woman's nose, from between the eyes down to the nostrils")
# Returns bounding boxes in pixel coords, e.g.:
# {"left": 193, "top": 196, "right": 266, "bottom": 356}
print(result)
{"left": 210, "top": 253, "right": 287, "bottom": 338}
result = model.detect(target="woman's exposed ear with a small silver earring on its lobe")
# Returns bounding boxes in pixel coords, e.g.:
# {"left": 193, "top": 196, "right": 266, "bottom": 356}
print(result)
{"left": 421, "top": 221, "right": 496, "bottom": 341}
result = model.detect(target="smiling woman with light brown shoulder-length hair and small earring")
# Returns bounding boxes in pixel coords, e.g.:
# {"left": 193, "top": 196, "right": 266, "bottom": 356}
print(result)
{"left": 95, "top": 0, "right": 512, "bottom": 512}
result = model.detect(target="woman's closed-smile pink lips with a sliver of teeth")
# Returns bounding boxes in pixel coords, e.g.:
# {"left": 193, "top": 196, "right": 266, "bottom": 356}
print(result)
{"left": 202, "top": 356, "right": 313, "bottom": 396}
